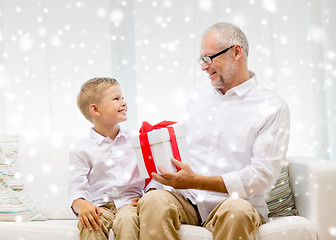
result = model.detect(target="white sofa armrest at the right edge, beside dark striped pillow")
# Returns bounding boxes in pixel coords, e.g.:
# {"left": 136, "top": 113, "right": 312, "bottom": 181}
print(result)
{"left": 288, "top": 157, "right": 336, "bottom": 240}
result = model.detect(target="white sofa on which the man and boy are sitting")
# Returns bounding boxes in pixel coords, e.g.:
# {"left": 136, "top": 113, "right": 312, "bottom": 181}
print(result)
{"left": 0, "top": 137, "right": 336, "bottom": 240}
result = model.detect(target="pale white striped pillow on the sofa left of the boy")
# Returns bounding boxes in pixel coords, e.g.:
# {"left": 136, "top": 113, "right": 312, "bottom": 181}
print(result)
{"left": 0, "top": 136, "right": 46, "bottom": 222}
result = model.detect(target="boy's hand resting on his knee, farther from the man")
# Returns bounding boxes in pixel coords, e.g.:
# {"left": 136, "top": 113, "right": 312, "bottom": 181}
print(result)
{"left": 73, "top": 199, "right": 103, "bottom": 231}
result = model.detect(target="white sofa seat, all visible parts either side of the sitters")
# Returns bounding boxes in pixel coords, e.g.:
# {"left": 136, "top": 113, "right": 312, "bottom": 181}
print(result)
{"left": 0, "top": 216, "right": 317, "bottom": 240}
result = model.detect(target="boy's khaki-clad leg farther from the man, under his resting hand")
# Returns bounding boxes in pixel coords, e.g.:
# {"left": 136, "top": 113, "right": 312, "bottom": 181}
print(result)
{"left": 77, "top": 203, "right": 116, "bottom": 240}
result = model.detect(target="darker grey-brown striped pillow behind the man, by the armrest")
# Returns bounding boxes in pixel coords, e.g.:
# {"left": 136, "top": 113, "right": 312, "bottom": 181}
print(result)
{"left": 266, "top": 164, "right": 297, "bottom": 218}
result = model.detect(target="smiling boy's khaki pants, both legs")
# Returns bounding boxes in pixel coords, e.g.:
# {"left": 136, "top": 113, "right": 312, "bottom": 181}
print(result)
{"left": 78, "top": 202, "right": 139, "bottom": 240}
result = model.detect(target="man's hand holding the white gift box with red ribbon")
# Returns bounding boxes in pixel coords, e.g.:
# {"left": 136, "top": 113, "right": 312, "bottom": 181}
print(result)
{"left": 152, "top": 158, "right": 198, "bottom": 189}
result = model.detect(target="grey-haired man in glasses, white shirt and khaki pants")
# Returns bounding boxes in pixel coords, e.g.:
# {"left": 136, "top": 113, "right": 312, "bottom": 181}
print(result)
{"left": 138, "top": 23, "right": 289, "bottom": 240}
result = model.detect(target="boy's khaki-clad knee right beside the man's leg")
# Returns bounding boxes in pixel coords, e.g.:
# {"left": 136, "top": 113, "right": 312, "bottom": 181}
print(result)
{"left": 112, "top": 205, "right": 139, "bottom": 240}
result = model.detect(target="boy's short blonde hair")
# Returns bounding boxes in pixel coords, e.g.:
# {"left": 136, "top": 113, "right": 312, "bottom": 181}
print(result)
{"left": 77, "top": 77, "right": 119, "bottom": 122}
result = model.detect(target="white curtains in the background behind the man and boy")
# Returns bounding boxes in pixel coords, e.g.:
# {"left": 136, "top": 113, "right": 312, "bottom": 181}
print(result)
{"left": 0, "top": 0, "right": 336, "bottom": 160}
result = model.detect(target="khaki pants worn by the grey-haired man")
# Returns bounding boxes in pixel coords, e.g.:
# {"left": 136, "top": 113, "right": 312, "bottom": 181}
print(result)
{"left": 138, "top": 190, "right": 265, "bottom": 240}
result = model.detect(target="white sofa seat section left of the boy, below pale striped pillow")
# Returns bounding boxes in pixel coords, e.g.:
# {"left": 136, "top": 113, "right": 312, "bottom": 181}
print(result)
{"left": 0, "top": 220, "right": 79, "bottom": 240}
